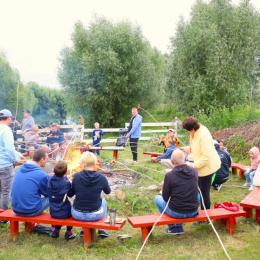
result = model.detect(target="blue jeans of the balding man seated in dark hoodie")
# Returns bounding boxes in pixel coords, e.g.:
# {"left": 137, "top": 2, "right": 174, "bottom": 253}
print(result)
{"left": 154, "top": 195, "right": 199, "bottom": 229}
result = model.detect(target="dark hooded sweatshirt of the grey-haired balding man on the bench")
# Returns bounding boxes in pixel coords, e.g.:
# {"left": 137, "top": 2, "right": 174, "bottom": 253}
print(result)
{"left": 162, "top": 164, "right": 199, "bottom": 213}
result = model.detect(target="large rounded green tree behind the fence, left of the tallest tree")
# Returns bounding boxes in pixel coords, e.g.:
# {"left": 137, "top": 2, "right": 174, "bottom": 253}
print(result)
{"left": 58, "top": 17, "right": 164, "bottom": 127}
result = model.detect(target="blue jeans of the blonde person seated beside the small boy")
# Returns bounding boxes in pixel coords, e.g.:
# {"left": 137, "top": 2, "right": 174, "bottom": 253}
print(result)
{"left": 71, "top": 199, "right": 107, "bottom": 222}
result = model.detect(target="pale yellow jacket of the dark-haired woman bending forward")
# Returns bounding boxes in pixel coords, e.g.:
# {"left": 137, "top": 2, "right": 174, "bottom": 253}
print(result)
{"left": 188, "top": 125, "right": 221, "bottom": 177}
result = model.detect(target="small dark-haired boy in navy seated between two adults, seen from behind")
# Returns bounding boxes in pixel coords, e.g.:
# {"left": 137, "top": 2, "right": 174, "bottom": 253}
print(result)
{"left": 48, "top": 161, "right": 77, "bottom": 240}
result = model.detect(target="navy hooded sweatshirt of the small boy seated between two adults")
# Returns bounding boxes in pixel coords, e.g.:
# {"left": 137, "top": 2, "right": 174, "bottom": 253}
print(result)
{"left": 48, "top": 175, "right": 74, "bottom": 218}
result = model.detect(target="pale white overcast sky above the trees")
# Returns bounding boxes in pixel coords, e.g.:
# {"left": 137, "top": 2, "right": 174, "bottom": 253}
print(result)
{"left": 0, "top": 0, "right": 260, "bottom": 88}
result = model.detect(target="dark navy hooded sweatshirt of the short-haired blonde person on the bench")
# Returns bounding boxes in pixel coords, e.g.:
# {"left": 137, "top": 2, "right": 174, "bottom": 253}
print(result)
{"left": 72, "top": 170, "right": 111, "bottom": 212}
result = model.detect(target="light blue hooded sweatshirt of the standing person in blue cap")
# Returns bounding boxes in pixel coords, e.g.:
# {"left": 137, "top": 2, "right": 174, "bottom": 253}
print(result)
{"left": 0, "top": 124, "right": 22, "bottom": 168}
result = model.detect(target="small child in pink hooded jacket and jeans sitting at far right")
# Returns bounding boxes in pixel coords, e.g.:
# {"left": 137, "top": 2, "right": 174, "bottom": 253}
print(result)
{"left": 243, "top": 147, "right": 259, "bottom": 190}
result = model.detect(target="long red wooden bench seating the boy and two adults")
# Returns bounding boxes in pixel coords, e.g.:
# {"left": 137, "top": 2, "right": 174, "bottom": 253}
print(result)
{"left": 0, "top": 209, "right": 126, "bottom": 248}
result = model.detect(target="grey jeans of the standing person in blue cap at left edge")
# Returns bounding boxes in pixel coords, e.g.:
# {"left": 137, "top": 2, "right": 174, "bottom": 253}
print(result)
{"left": 0, "top": 165, "right": 14, "bottom": 210}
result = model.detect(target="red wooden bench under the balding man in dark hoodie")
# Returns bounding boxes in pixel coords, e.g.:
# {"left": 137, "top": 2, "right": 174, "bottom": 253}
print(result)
{"left": 128, "top": 209, "right": 246, "bottom": 244}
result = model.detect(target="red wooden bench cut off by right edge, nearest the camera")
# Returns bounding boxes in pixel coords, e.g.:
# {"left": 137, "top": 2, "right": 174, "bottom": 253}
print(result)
{"left": 240, "top": 187, "right": 260, "bottom": 222}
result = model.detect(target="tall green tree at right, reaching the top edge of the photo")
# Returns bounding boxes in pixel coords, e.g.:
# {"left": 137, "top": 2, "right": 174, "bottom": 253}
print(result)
{"left": 168, "top": 0, "right": 260, "bottom": 115}
